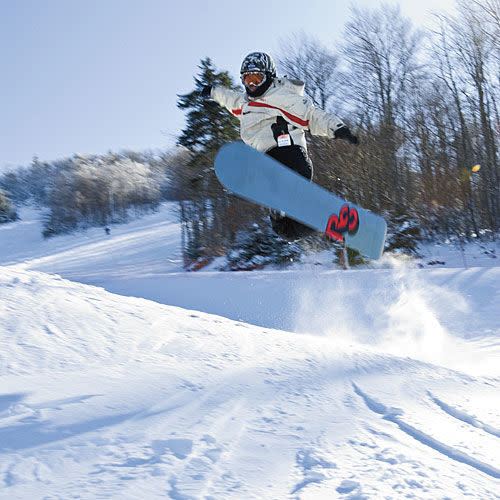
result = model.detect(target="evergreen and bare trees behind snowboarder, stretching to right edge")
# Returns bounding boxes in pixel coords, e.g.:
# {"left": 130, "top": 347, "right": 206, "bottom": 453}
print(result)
{"left": 176, "top": 0, "right": 500, "bottom": 270}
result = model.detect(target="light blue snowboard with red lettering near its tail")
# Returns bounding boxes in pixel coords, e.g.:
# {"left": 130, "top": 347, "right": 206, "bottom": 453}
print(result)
{"left": 214, "top": 142, "right": 387, "bottom": 259}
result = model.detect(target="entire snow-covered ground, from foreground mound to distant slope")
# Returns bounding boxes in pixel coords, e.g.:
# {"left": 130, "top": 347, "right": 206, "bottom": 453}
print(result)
{"left": 0, "top": 205, "right": 500, "bottom": 500}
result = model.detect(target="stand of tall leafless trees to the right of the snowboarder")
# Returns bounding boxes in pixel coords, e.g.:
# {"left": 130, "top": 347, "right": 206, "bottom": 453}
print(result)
{"left": 300, "top": 0, "right": 500, "bottom": 242}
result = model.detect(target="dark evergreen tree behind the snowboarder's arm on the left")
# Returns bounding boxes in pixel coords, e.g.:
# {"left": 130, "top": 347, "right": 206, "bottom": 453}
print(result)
{"left": 174, "top": 58, "right": 262, "bottom": 267}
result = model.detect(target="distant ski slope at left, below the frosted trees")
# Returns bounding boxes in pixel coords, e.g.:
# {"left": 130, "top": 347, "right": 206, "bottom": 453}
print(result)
{"left": 0, "top": 204, "right": 182, "bottom": 281}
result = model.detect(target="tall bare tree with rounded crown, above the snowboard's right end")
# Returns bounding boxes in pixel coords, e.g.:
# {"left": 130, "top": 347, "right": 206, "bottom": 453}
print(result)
{"left": 344, "top": 5, "right": 423, "bottom": 211}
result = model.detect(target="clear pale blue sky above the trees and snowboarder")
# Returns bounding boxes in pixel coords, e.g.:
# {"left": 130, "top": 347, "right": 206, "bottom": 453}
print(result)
{"left": 0, "top": 0, "right": 453, "bottom": 171}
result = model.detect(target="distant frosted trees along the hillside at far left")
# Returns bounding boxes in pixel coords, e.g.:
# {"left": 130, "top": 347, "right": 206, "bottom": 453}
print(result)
{"left": 0, "top": 151, "right": 184, "bottom": 237}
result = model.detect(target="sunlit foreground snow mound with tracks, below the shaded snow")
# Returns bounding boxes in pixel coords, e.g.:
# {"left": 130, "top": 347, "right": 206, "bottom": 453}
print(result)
{"left": 0, "top": 267, "right": 500, "bottom": 499}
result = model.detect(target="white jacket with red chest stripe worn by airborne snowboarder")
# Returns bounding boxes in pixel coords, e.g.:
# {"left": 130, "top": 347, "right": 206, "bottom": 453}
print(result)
{"left": 211, "top": 77, "right": 344, "bottom": 152}
